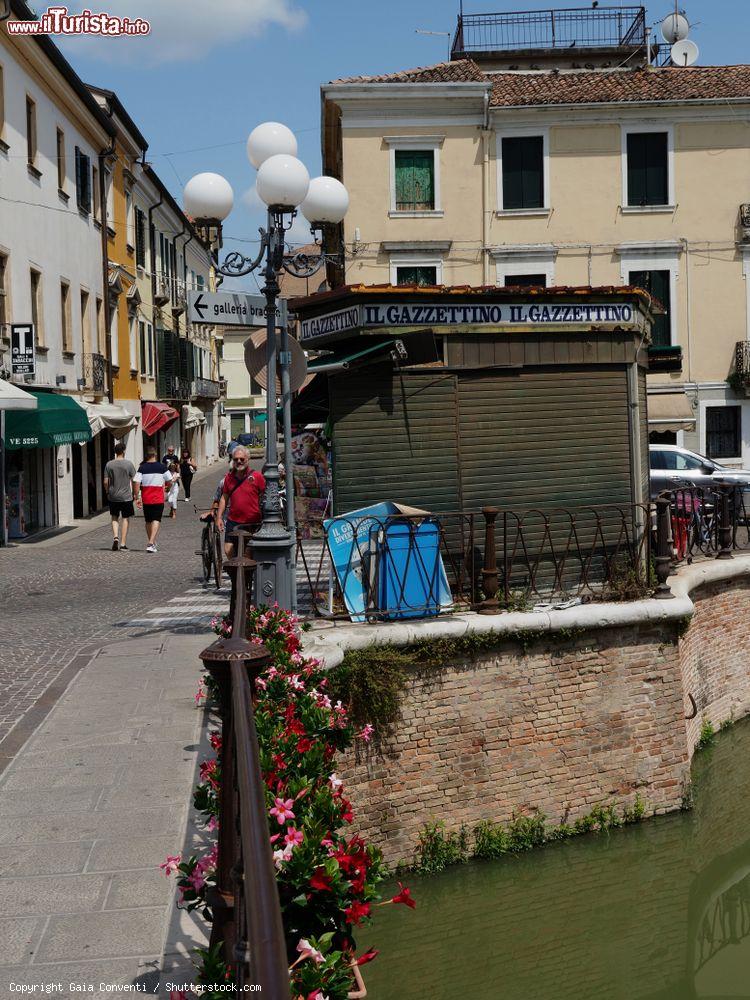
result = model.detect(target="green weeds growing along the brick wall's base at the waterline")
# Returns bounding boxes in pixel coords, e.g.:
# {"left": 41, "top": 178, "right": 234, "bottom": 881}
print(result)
{"left": 412, "top": 794, "right": 646, "bottom": 875}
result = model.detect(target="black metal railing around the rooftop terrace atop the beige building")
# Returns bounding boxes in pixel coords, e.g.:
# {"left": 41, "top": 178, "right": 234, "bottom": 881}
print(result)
{"left": 451, "top": 6, "right": 646, "bottom": 59}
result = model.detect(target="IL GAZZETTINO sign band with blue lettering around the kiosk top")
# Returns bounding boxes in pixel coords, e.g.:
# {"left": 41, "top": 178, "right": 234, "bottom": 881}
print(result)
{"left": 300, "top": 299, "right": 636, "bottom": 340}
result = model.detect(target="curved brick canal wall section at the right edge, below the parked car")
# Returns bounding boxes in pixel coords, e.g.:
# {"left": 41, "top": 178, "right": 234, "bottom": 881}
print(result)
{"left": 680, "top": 579, "right": 750, "bottom": 752}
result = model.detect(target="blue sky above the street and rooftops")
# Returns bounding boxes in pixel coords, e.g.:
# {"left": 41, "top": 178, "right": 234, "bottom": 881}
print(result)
{"left": 51, "top": 0, "right": 750, "bottom": 290}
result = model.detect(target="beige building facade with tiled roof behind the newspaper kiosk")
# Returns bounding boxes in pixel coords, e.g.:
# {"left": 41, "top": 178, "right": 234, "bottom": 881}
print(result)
{"left": 323, "top": 59, "right": 750, "bottom": 467}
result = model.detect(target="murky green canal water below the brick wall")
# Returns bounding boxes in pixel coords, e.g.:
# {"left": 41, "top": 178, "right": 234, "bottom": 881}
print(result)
{"left": 368, "top": 720, "right": 750, "bottom": 1000}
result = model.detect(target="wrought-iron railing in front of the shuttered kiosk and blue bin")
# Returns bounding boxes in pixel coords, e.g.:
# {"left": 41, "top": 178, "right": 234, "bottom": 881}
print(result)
{"left": 297, "top": 504, "right": 652, "bottom": 621}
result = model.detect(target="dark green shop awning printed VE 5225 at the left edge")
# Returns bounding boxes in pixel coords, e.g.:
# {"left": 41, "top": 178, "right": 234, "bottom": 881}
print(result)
{"left": 5, "top": 389, "right": 91, "bottom": 451}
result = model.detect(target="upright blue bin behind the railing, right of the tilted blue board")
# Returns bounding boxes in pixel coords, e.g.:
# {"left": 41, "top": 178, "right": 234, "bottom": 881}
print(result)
{"left": 373, "top": 517, "right": 444, "bottom": 621}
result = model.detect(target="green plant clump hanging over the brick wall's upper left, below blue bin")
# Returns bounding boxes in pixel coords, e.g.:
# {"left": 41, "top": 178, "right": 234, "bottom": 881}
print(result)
{"left": 328, "top": 646, "right": 413, "bottom": 734}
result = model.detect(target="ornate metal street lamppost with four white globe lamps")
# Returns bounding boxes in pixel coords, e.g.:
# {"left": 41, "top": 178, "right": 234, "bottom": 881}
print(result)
{"left": 183, "top": 122, "right": 349, "bottom": 608}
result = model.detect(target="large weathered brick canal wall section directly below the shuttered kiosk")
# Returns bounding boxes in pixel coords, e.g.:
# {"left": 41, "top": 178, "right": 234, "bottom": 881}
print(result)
{"left": 341, "top": 626, "right": 689, "bottom": 861}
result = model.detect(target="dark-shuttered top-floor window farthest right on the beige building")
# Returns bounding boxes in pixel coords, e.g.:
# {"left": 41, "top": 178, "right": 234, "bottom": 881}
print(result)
{"left": 623, "top": 128, "right": 674, "bottom": 209}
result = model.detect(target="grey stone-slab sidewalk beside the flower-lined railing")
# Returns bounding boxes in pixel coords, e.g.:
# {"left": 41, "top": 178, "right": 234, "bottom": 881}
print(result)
{"left": 0, "top": 631, "right": 212, "bottom": 1000}
